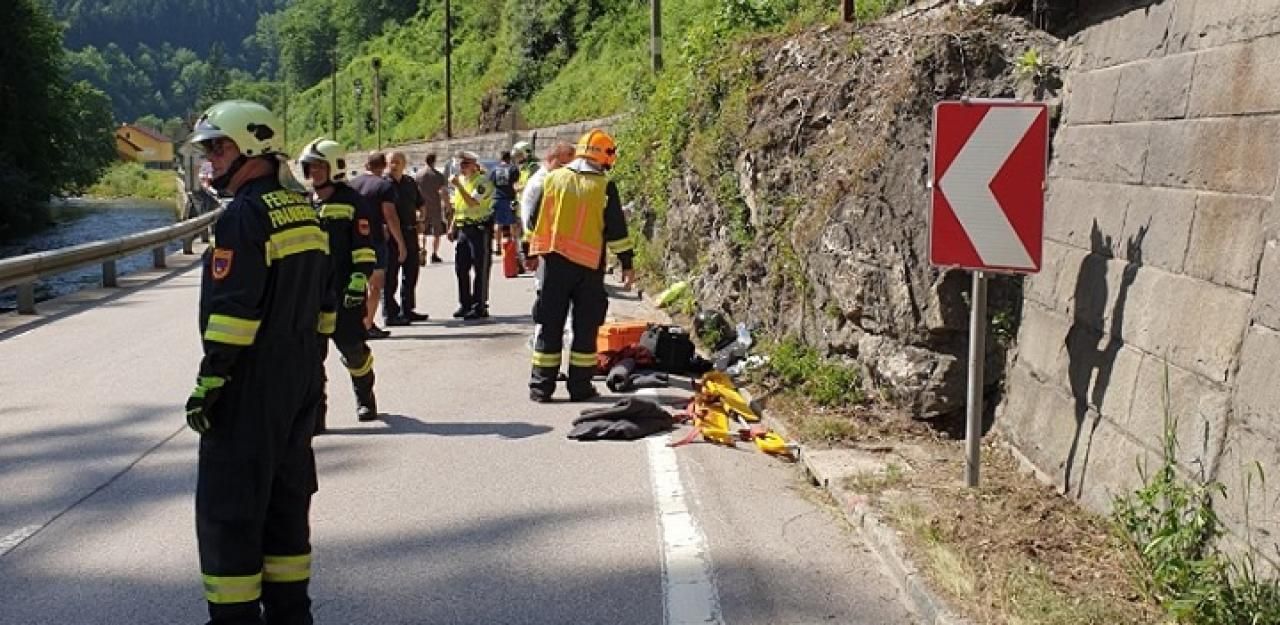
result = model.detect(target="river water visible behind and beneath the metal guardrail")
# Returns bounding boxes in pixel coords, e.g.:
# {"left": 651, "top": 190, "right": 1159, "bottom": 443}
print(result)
{"left": 0, "top": 200, "right": 182, "bottom": 311}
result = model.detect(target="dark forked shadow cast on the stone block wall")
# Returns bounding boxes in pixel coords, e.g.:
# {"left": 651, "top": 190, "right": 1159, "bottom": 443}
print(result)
{"left": 1062, "top": 220, "right": 1151, "bottom": 497}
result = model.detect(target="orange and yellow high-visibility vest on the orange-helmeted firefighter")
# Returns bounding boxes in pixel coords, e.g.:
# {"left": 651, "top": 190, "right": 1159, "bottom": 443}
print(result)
{"left": 529, "top": 168, "right": 609, "bottom": 269}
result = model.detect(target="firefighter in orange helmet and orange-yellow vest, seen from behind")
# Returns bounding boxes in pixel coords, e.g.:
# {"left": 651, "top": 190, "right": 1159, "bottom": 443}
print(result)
{"left": 527, "top": 129, "right": 635, "bottom": 402}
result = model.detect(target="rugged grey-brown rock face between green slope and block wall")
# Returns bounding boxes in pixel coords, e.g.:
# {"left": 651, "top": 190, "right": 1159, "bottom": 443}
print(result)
{"left": 640, "top": 8, "right": 1057, "bottom": 418}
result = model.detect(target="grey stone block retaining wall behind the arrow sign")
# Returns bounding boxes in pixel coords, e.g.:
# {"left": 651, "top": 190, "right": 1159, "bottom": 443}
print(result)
{"left": 997, "top": 0, "right": 1280, "bottom": 560}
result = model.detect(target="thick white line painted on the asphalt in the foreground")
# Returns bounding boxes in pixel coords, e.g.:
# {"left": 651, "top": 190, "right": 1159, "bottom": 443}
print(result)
{"left": 648, "top": 437, "right": 724, "bottom": 625}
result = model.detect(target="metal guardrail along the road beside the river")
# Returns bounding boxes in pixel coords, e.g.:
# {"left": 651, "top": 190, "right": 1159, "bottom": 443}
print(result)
{"left": 0, "top": 209, "right": 223, "bottom": 315}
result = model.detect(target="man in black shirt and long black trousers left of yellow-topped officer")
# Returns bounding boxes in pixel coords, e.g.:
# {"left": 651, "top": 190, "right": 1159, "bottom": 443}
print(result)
{"left": 383, "top": 152, "right": 428, "bottom": 325}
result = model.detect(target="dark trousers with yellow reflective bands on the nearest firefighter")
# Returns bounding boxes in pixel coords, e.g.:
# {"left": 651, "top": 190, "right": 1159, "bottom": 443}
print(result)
{"left": 196, "top": 334, "right": 321, "bottom": 625}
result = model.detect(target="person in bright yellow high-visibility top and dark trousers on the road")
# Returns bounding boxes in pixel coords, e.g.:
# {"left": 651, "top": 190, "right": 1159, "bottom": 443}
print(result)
{"left": 449, "top": 151, "right": 493, "bottom": 320}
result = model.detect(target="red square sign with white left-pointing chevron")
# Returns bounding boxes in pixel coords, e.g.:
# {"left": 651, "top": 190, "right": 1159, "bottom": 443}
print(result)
{"left": 929, "top": 101, "right": 1048, "bottom": 273}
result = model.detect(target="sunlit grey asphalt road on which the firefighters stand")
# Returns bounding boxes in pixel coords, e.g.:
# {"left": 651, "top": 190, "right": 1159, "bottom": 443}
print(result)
{"left": 0, "top": 243, "right": 914, "bottom": 625}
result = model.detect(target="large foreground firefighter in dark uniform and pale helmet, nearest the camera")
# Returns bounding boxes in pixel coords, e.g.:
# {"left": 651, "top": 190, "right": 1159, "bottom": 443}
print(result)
{"left": 187, "top": 100, "right": 330, "bottom": 625}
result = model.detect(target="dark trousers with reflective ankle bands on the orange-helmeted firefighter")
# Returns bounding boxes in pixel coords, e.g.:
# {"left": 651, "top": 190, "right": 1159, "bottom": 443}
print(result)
{"left": 529, "top": 254, "right": 609, "bottom": 398}
